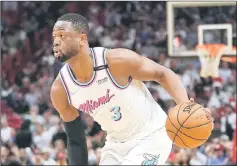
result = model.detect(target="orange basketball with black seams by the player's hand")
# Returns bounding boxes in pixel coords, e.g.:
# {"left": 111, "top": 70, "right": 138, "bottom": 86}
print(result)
{"left": 166, "top": 102, "right": 213, "bottom": 148}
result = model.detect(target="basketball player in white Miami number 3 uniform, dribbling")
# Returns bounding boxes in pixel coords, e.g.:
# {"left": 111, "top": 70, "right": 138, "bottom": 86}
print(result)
{"left": 50, "top": 13, "right": 197, "bottom": 165}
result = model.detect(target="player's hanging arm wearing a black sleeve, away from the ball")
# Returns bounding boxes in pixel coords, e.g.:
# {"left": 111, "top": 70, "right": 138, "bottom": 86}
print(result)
{"left": 50, "top": 78, "right": 88, "bottom": 165}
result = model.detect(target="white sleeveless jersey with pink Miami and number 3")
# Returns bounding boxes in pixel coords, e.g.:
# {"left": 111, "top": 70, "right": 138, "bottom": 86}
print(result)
{"left": 60, "top": 47, "right": 166, "bottom": 141}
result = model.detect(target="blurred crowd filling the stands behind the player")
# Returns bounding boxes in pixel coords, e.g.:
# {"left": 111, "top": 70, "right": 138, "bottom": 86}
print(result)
{"left": 1, "top": 1, "right": 236, "bottom": 165}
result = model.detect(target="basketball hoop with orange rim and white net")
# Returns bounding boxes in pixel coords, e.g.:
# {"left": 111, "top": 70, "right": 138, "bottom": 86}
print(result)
{"left": 196, "top": 44, "right": 228, "bottom": 77}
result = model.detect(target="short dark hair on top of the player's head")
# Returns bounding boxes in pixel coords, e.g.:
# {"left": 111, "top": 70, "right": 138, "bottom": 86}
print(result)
{"left": 57, "top": 13, "right": 89, "bottom": 35}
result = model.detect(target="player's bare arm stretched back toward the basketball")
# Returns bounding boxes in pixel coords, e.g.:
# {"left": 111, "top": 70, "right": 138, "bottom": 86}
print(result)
{"left": 107, "top": 48, "right": 189, "bottom": 104}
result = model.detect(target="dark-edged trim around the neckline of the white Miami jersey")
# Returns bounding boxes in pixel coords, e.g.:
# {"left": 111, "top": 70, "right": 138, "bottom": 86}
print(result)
{"left": 67, "top": 48, "right": 97, "bottom": 86}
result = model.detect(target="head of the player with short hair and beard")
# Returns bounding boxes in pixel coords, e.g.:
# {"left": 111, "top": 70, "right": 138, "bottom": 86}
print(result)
{"left": 52, "top": 13, "right": 89, "bottom": 62}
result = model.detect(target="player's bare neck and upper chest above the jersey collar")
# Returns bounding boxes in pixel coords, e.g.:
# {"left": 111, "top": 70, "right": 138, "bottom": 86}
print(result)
{"left": 68, "top": 47, "right": 94, "bottom": 80}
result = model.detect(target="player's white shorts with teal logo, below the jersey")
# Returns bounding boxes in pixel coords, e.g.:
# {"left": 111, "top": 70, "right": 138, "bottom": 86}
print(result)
{"left": 100, "top": 127, "right": 172, "bottom": 166}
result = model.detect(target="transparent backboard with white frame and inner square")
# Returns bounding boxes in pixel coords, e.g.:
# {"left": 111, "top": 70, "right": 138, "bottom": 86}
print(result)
{"left": 167, "top": 1, "right": 236, "bottom": 57}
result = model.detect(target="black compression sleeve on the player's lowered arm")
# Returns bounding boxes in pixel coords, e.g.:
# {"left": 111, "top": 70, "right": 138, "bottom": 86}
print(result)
{"left": 64, "top": 117, "right": 88, "bottom": 165}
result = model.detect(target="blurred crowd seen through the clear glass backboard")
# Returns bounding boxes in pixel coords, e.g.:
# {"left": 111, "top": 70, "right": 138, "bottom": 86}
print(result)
{"left": 173, "top": 6, "right": 237, "bottom": 51}
